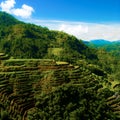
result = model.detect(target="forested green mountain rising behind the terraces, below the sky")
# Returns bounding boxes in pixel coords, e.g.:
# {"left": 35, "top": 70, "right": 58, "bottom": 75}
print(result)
{"left": 0, "top": 13, "right": 97, "bottom": 61}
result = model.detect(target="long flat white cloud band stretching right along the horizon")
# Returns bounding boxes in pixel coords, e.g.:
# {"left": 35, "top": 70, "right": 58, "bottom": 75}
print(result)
{"left": 27, "top": 20, "right": 120, "bottom": 41}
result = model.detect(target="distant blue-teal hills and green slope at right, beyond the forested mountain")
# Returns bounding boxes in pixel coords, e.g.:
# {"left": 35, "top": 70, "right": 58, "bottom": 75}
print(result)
{"left": 86, "top": 40, "right": 120, "bottom": 80}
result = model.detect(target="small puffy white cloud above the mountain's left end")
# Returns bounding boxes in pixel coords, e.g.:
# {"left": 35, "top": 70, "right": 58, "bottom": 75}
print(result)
{"left": 0, "top": 0, "right": 34, "bottom": 18}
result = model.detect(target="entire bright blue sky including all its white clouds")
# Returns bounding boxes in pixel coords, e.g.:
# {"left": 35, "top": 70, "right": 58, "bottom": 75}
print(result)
{"left": 0, "top": 0, "right": 120, "bottom": 41}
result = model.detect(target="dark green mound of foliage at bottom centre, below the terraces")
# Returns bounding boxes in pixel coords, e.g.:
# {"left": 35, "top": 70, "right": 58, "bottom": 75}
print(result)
{"left": 28, "top": 85, "right": 115, "bottom": 120}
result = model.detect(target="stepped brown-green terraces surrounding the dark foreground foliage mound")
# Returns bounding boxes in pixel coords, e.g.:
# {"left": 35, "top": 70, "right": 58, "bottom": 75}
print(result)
{"left": 0, "top": 54, "right": 120, "bottom": 120}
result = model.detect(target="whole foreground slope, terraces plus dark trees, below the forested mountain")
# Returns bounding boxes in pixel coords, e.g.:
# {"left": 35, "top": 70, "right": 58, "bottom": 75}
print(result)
{"left": 0, "top": 54, "right": 120, "bottom": 120}
